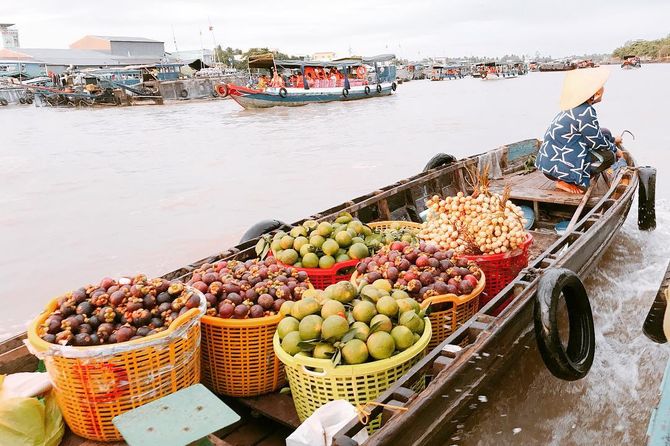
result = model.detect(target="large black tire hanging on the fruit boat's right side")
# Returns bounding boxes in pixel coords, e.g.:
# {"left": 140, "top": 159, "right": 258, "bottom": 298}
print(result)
{"left": 533, "top": 268, "right": 596, "bottom": 381}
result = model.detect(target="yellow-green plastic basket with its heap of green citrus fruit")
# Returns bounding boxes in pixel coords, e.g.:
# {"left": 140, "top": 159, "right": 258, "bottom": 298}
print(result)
{"left": 273, "top": 280, "right": 431, "bottom": 430}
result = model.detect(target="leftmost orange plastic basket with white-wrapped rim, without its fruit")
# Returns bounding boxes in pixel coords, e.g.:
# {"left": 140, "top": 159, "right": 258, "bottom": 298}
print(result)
{"left": 28, "top": 289, "right": 206, "bottom": 441}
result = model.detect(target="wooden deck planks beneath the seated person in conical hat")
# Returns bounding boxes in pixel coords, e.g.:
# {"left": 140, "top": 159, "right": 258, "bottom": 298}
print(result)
{"left": 490, "top": 170, "right": 608, "bottom": 207}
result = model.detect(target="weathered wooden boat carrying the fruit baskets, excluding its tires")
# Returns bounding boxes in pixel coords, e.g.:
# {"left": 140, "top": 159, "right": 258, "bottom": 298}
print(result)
{"left": 0, "top": 139, "right": 652, "bottom": 446}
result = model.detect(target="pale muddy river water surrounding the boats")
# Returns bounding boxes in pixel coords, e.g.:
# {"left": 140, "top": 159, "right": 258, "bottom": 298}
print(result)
{"left": 0, "top": 65, "right": 670, "bottom": 445}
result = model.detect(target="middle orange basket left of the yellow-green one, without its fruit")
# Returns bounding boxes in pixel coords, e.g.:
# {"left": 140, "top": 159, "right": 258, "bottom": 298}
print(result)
{"left": 201, "top": 314, "right": 286, "bottom": 397}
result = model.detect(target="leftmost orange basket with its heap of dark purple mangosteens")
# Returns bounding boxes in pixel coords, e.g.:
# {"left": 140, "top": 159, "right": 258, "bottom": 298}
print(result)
{"left": 28, "top": 275, "right": 205, "bottom": 441}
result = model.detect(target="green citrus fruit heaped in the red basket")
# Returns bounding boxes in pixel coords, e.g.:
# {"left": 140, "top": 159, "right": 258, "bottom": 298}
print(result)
{"left": 270, "top": 213, "right": 372, "bottom": 268}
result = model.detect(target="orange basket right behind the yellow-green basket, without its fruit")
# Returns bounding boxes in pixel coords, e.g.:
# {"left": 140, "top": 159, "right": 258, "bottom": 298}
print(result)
{"left": 351, "top": 271, "right": 486, "bottom": 350}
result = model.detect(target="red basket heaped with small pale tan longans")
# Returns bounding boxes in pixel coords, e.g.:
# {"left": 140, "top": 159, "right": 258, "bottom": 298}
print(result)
{"left": 420, "top": 172, "right": 533, "bottom": 310}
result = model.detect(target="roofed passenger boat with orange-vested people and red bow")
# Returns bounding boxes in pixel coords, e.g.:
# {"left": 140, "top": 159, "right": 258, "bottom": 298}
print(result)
{"left": 226, "top": 54, "right": 397, "bottom": 108}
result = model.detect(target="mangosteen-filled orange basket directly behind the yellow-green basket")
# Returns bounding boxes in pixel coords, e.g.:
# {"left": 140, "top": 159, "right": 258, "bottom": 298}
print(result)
{"left": 352, "top": 241, "right": 486, "bottom": 349}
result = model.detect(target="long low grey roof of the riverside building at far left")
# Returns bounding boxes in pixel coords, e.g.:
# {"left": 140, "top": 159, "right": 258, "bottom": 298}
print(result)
{"left": 0, "top": 48, "right": 160, "bottom": 66}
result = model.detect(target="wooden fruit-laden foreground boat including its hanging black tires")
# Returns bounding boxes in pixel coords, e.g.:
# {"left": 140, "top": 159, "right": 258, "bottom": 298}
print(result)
{"left": 0, "top": 139, "right": 654, "bottom": 446}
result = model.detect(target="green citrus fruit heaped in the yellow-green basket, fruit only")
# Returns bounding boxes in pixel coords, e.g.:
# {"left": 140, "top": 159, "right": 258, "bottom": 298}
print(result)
{"left": 277, "top": 279, "right": 426, "bottom": 365}
